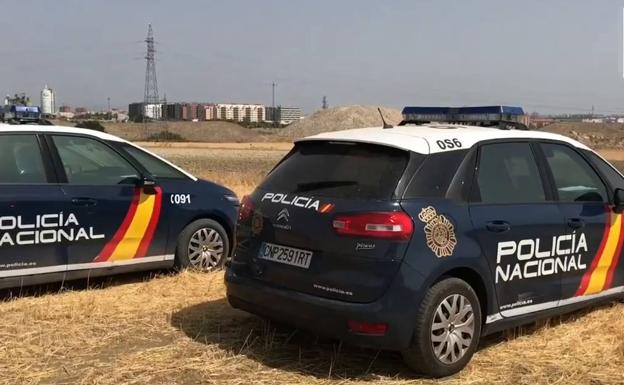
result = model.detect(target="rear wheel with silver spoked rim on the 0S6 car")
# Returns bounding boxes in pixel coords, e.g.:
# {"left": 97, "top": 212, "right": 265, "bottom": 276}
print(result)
{"left": 402, "top": 278, "right": 482, "bottom": 378}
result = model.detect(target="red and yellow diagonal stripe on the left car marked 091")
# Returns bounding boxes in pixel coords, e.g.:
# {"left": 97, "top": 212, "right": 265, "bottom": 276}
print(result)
{"left": 95, "top": 187, "right": 162, "bottom": 262}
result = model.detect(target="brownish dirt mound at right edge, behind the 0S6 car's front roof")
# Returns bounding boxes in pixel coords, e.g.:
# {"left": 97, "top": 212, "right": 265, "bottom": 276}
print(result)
{"left": 542, "top": 122, "right": 624, "bottom": 149}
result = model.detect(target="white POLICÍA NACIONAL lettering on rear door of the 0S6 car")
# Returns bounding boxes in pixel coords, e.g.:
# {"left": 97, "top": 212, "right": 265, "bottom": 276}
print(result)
{"left": 496, "top": 233, "right": 587, "bottom": 283}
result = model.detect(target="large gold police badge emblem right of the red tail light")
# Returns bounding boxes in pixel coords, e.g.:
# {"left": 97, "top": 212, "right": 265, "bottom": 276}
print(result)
{"left": 418, "top": 206, "right": 457, "bottom": 258}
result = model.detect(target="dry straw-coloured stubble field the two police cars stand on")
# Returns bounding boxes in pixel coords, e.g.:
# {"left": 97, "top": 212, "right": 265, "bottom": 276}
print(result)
{"left": 0, "top": 143, "right": 624, "bottom": 385}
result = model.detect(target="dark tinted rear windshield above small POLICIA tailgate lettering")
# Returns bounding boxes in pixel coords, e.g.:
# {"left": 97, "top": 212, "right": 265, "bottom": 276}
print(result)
{"left": 260, "top": 141, "right": 409, "bottom": 199}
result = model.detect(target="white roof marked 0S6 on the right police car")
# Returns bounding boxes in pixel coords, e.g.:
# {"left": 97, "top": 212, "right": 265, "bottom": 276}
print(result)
{"left": 296, "top": 123, "right": 589, "bottom": 154}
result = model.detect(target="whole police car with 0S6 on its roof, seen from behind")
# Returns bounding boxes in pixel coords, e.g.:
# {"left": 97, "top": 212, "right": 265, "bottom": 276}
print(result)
{"left": 226, "top": 106, "right": 624, "bottom": 376}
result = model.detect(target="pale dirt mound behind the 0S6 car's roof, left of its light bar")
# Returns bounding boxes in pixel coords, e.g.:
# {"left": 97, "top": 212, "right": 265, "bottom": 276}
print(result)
{"left": 280, "top": 105, "right": 401, "bottom": 138}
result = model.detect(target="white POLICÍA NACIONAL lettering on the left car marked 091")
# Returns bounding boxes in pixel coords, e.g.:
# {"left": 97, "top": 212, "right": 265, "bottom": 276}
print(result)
{"left": 0, "top": 212, "right": 104, "bottom": 246}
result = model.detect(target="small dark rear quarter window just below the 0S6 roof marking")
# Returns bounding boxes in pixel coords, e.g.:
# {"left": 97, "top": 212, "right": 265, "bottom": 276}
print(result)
{"left": 404, "top": 150, "right": 468, "bottom": 198}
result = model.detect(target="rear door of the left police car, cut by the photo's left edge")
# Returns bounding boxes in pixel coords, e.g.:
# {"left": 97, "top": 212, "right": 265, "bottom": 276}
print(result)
{"left": 0, "top": 133, "right": 67, "bottom": 280}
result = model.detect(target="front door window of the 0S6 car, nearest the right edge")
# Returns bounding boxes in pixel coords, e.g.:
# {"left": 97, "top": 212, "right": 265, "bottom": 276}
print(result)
{"left": 541, "top": 143, "right": 607, "bottom": 202}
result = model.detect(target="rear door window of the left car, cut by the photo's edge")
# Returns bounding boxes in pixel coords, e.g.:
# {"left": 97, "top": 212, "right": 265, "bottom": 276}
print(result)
{"left": 0, "top": 135, "right": 47, "bottom": 184}
